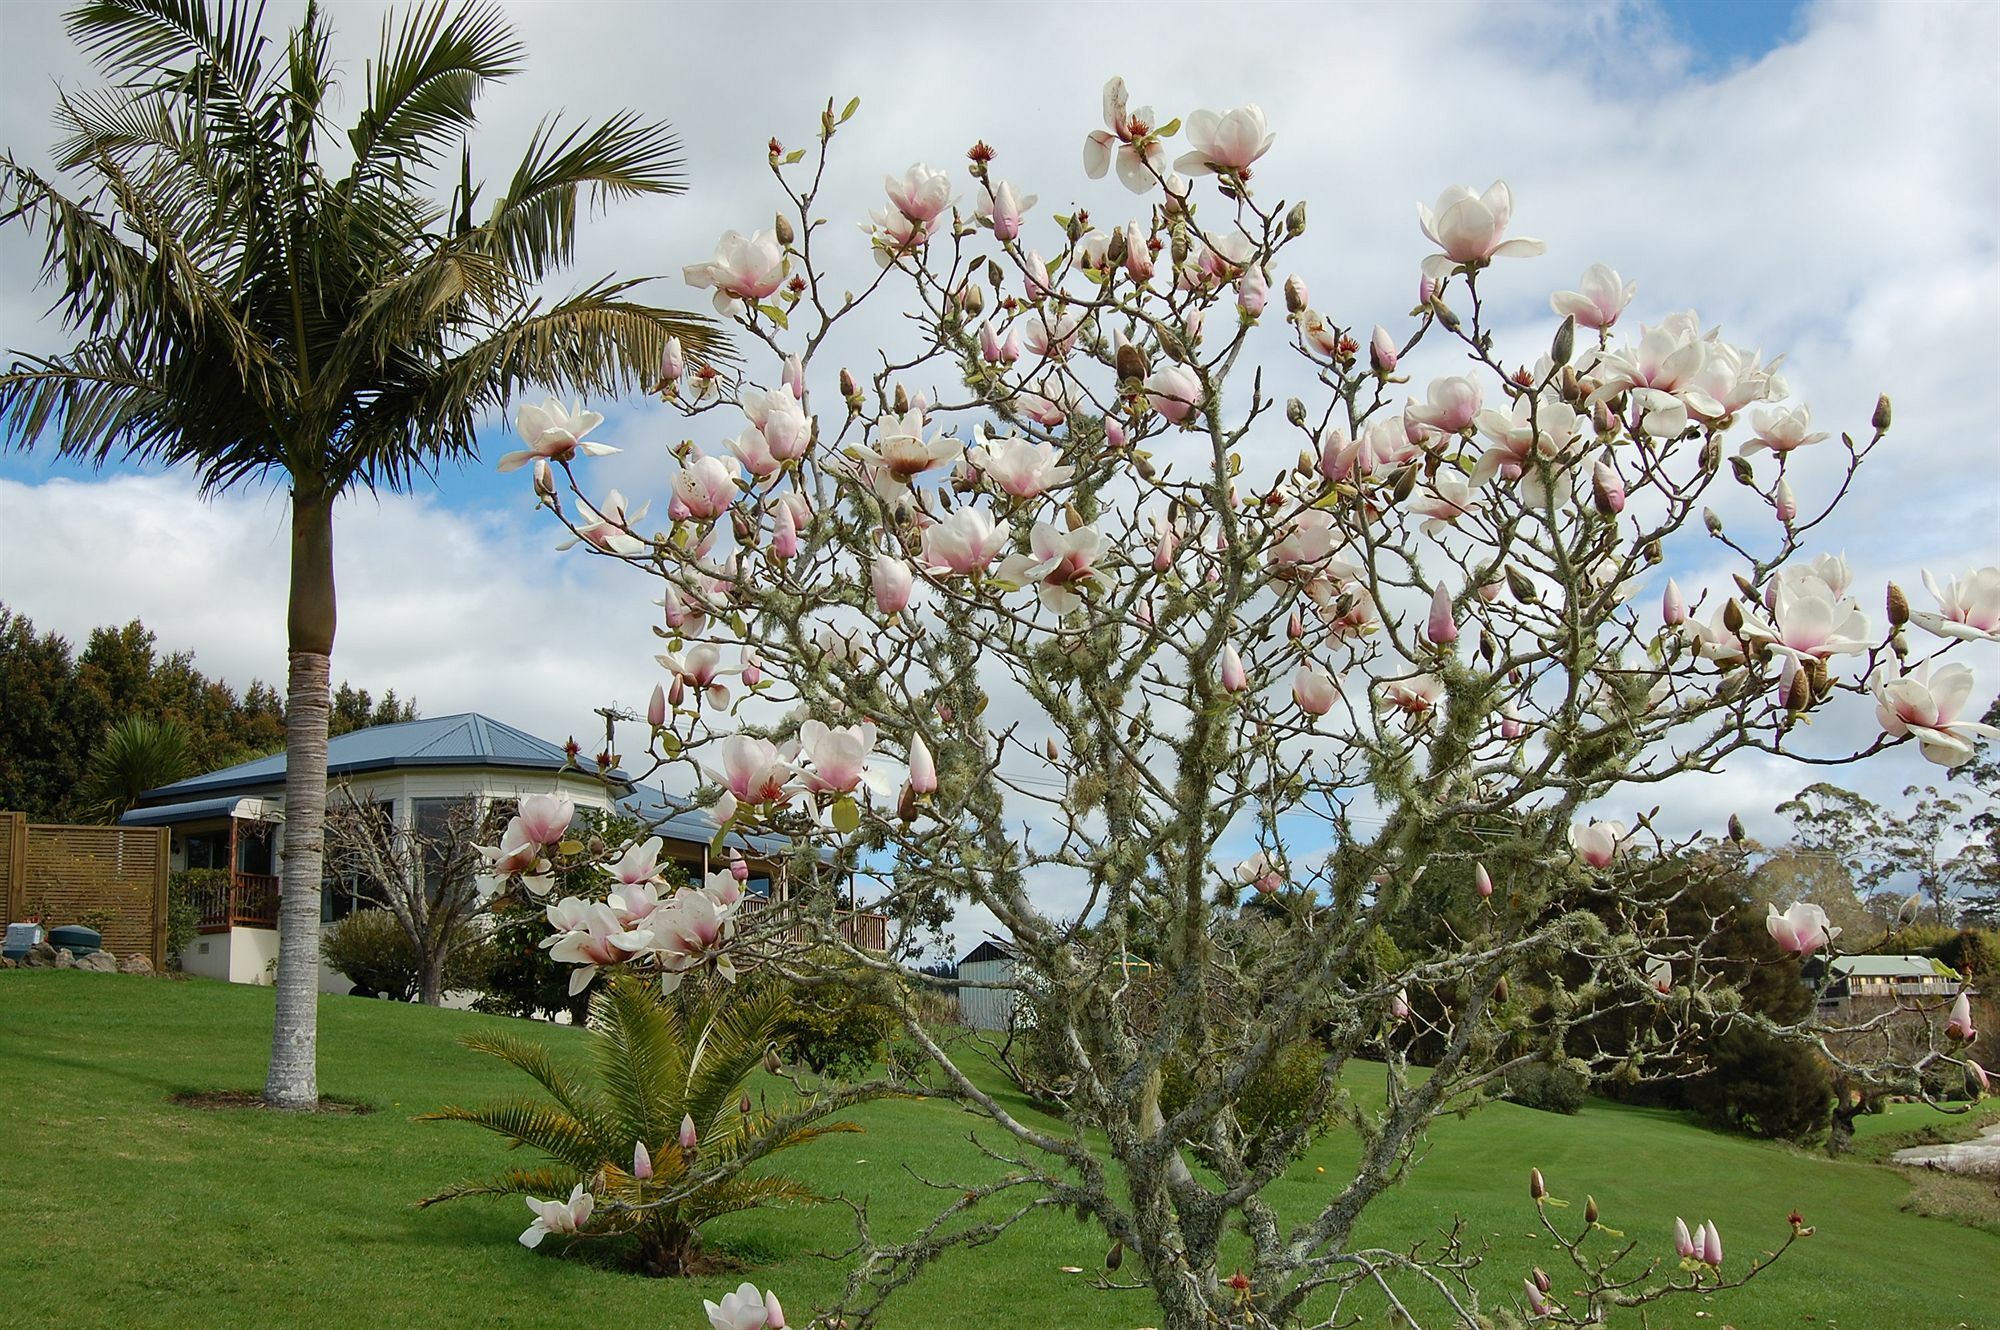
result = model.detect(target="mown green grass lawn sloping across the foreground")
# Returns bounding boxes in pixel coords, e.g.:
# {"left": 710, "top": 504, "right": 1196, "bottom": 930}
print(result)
{"left": 0, "top": 972, "right": 2000, "bottom": 1330}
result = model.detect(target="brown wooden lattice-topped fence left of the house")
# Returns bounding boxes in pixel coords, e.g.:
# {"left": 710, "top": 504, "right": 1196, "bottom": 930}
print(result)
{"left": 0, "top": 812, "right": 168, "bottom": 970}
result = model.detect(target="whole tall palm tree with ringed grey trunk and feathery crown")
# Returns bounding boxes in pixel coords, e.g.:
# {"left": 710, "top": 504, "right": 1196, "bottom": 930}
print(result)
{"left": 0, "top": 0, "right": 712, "bottom": 1108}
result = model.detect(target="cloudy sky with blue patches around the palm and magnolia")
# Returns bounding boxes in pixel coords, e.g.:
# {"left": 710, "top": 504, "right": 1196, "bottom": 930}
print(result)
{"left": 0, "top": 0, "right": 2000, "bottom": 948}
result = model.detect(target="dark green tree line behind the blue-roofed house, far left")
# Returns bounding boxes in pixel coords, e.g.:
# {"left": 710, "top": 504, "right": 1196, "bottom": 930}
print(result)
{"left": 0, "top": 604, "right": 416, "bottom": 822}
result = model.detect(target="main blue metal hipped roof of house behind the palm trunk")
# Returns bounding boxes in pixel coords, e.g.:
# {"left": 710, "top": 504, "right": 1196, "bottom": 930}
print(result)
{"left": 129, "top": 712, "right": 622, "bottom": 806}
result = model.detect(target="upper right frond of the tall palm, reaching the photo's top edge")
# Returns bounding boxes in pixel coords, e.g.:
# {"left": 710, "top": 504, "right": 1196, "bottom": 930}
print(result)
{"left": 348, "top": 0, "right": 524, "bottom": 182}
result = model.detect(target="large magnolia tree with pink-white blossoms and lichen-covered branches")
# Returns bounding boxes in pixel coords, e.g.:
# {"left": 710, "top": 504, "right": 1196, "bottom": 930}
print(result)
{"left": 488, "top": 80, "right": 2000, "bottom": 1330}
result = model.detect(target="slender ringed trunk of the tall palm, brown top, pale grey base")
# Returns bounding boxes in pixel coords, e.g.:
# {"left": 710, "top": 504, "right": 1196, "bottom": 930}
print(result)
{"left": 264, "top": 490, "right": 334, "bottom": 1110}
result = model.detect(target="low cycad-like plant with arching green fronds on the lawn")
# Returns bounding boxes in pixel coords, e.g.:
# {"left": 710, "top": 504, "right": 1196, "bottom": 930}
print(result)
{"left": 422, "top": 976, "right": 874, "bottom": 1276}
